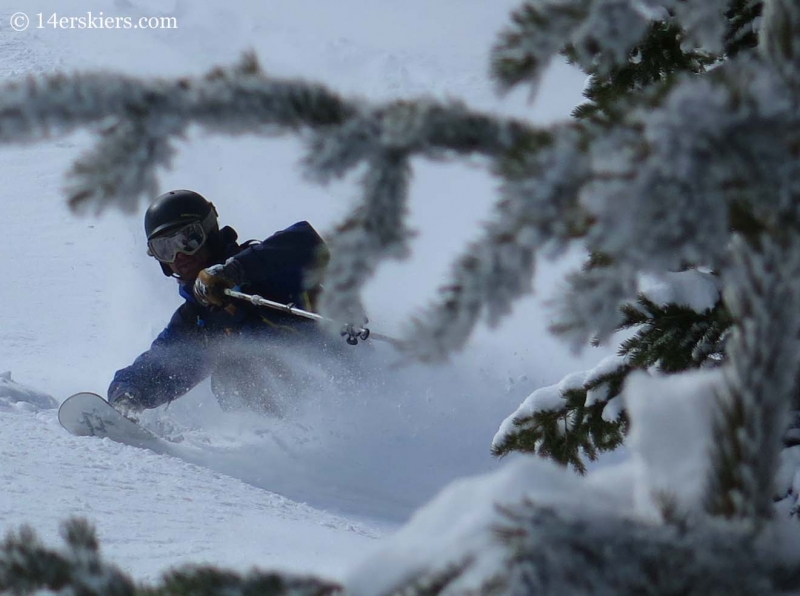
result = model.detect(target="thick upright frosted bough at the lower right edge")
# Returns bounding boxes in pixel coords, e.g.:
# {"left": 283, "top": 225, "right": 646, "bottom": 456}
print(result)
{"left": 706, "top": 231, "right": 800, "bottom": 521}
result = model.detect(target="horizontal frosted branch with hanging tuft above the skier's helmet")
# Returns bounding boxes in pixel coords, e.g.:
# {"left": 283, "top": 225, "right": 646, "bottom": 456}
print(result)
{"left": 0, "top": 55, "right": 355, "bottom": 211}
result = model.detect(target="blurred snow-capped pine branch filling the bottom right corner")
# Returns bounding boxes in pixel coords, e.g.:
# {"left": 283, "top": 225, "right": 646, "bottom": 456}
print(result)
{"left": 357, "top": 492, "right": 800, "bottom": 596}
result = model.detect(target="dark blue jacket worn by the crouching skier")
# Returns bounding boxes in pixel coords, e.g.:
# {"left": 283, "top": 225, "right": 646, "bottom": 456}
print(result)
{"left": 108, "top": 221, "right": 329, "bottom": 408}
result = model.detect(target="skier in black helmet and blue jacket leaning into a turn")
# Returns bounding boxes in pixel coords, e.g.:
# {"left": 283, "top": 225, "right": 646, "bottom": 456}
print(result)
{"left": 108, "top": 190, "right": 335, "bottom": 418}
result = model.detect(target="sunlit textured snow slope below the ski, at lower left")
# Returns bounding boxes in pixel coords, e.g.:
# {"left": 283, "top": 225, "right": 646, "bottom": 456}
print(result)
{"left": 0, "top": 380, "right": 379, "bottom": 579}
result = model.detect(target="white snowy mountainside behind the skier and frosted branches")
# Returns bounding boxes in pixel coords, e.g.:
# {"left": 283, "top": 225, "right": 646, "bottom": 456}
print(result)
{"left": 0, "top": 0, "right": 605, "bottom": 580}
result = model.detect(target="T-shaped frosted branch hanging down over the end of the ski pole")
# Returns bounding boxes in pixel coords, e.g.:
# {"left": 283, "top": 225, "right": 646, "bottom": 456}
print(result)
{"left": 305, "top": 100, "right": 536, "bottom": 330}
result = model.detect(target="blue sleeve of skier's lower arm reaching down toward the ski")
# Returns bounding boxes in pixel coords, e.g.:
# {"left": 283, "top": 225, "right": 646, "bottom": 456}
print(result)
{"left": 108, "top": 305, "right": 209, "bottom": 408}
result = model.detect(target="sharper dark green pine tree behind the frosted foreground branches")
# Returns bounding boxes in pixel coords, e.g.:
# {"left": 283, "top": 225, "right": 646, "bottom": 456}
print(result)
{"left": 492, "top": 0, "right": 763, "bottom": 472}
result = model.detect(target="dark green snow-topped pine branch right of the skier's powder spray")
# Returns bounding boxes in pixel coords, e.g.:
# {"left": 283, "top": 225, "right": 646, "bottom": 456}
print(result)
{"left": 504, "top": 266, "right": 733, "bottom": 472}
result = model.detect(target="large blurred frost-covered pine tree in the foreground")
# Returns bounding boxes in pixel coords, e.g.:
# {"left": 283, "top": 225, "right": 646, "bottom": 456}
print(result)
{"left": 0, "top": 0, "right": 800, "bottom": 596}
